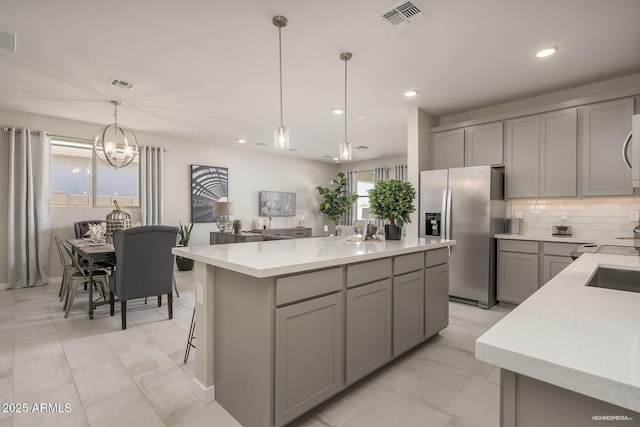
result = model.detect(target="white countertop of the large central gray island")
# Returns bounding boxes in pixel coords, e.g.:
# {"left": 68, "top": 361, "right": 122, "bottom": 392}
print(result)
{"left": 173, "top": 236, "right": 456, "bottom": 278}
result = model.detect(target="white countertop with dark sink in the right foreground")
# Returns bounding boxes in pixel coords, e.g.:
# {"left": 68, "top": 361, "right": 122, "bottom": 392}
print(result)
{"left": 476, "top": 249, "right": 640, "bottom": 412}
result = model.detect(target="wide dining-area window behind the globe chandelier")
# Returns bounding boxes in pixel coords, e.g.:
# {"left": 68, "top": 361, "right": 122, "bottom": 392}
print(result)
{"left": 51, "top": 139, "right": 140, "bottom": 207}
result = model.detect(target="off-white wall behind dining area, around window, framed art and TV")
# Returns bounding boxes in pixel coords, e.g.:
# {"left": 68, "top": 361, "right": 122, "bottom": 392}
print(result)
{"left": 0, "top": 109, "right": 338, "bottom": 288}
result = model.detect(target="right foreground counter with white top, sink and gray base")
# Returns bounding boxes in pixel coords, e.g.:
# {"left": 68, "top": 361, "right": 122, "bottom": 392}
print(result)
{"left": 476, "top": 246, "right": 640, "bottom": 427}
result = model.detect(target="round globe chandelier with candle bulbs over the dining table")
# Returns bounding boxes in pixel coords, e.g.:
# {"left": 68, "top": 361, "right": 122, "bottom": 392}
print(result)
{"left": 93, "top": 101, "right": 138, "bottom": 169}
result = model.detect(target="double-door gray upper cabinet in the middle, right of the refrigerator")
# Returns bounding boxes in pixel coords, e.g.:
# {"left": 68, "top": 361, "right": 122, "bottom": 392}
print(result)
{"left": 505, "top": 108, "right": 577, "bottom": 198}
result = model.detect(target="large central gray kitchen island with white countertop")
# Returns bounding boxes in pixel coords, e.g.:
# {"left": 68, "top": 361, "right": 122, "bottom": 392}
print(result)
{"left": 173, "top": 237, "right": 455, "bottom": 426}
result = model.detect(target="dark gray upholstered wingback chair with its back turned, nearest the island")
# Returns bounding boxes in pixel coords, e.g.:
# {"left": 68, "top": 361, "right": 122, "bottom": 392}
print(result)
{"left": 109, "top": 225, "right": 178, "bottom": 329}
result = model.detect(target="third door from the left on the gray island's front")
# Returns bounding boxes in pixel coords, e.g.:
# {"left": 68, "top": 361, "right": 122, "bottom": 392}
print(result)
{"left": 393, "top": 270, "right": 424, "bottom": 357}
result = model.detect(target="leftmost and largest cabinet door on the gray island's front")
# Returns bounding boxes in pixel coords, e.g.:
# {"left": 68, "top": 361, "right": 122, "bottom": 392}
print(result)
{"left": 276, "top": 292, "right": 344, "bottom": 426}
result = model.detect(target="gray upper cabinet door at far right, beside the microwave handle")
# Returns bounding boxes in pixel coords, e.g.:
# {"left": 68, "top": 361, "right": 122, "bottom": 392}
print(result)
{"left": 580, "top": 98, "right": 634, "bottom": 196}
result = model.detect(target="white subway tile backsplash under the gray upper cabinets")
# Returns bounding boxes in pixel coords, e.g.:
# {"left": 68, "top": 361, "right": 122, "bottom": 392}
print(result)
{"left": 507, "top": 197, "right": 640, "bottom": 239}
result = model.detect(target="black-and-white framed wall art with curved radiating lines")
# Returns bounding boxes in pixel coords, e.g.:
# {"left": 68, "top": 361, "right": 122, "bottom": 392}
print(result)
{"left": 191, "top": 165, "right": 229, "bottom": 222}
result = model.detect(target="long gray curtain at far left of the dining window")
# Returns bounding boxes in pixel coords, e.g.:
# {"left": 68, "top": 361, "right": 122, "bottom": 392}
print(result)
{"left": 7, "top": 127, "right": 51, "bottom": 288}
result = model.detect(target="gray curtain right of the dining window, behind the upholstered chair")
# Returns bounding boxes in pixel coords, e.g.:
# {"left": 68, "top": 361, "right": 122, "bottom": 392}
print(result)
{"left": 140, "top": 146, "right": 164, "bottom": 225}
